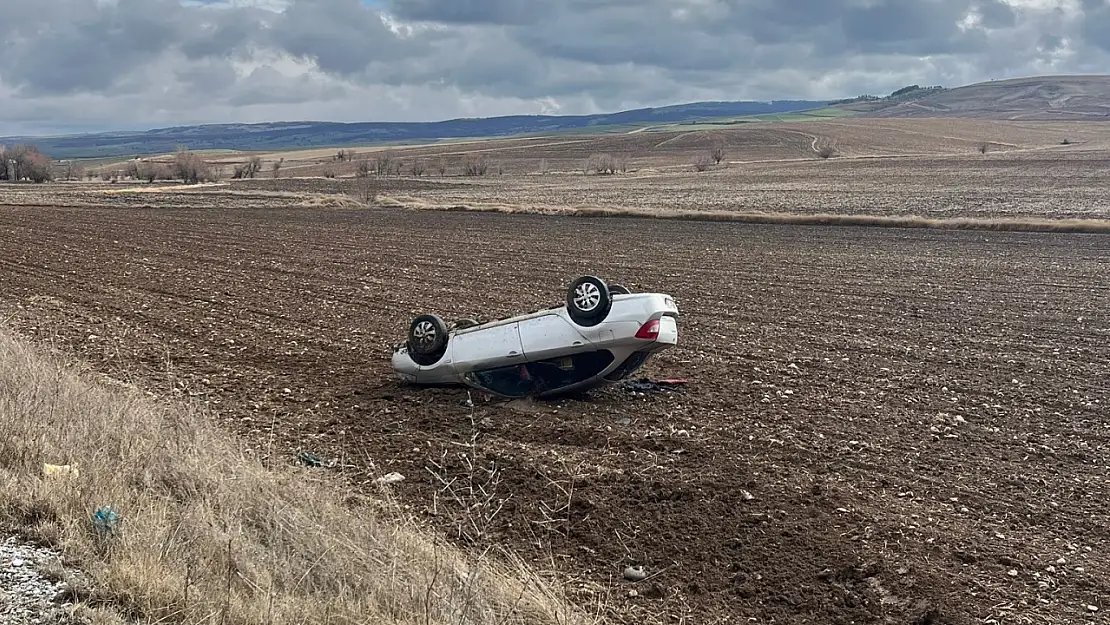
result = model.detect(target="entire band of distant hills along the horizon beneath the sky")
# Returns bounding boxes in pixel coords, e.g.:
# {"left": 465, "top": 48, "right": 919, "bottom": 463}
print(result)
{"left": 8, "top": 75, "right": 1110, "bottom": 159}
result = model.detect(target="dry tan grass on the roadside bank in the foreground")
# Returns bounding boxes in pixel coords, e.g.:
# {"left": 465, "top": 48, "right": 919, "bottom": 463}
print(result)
{"left": 0, "top": 332, "right": 584, "bottom": 625}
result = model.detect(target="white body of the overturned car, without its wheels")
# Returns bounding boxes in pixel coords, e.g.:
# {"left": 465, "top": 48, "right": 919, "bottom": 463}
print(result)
{"left": 392, "top": 293, "right": 678, "bottom": 397}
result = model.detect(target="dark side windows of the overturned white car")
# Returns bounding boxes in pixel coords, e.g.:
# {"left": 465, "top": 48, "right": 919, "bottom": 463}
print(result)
{"left": 467, "top": 350, "right": 613, "bottom": 397}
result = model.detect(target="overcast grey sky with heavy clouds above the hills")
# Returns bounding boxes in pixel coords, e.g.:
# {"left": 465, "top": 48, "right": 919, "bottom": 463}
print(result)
{"left": 0, "top": 0, "right": 1110, "bottom": 135}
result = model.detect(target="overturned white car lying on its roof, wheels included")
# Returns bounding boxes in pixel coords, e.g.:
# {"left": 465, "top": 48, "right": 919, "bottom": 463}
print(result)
{"left": 393, "top": 275, "right": 678, "bottom": 397}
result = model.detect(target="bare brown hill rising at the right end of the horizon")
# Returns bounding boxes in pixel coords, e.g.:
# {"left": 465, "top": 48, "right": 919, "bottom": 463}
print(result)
{"left": 838, "top": 75, "right": 1110, "bottom": 121}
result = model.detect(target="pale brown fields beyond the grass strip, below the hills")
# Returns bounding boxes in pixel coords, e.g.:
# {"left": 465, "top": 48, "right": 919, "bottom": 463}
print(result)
{"left": 64, "top": 120, "right": 1110, "bottom": 220}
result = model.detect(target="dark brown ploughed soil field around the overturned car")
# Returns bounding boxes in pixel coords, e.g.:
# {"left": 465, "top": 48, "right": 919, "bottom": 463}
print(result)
{"left": 0, "top": 208, "right": 1110, "bottom": 624}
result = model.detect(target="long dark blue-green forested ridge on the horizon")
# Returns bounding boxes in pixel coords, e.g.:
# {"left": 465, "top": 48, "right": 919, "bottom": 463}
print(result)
{"left": 0, "top": 100, "right": 825, "bottom": 159}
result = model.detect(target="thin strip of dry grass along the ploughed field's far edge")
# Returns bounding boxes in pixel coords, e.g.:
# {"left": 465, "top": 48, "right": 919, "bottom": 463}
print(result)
{"left": 379, "top": 196, "right": 1110, "bottom": 233}
